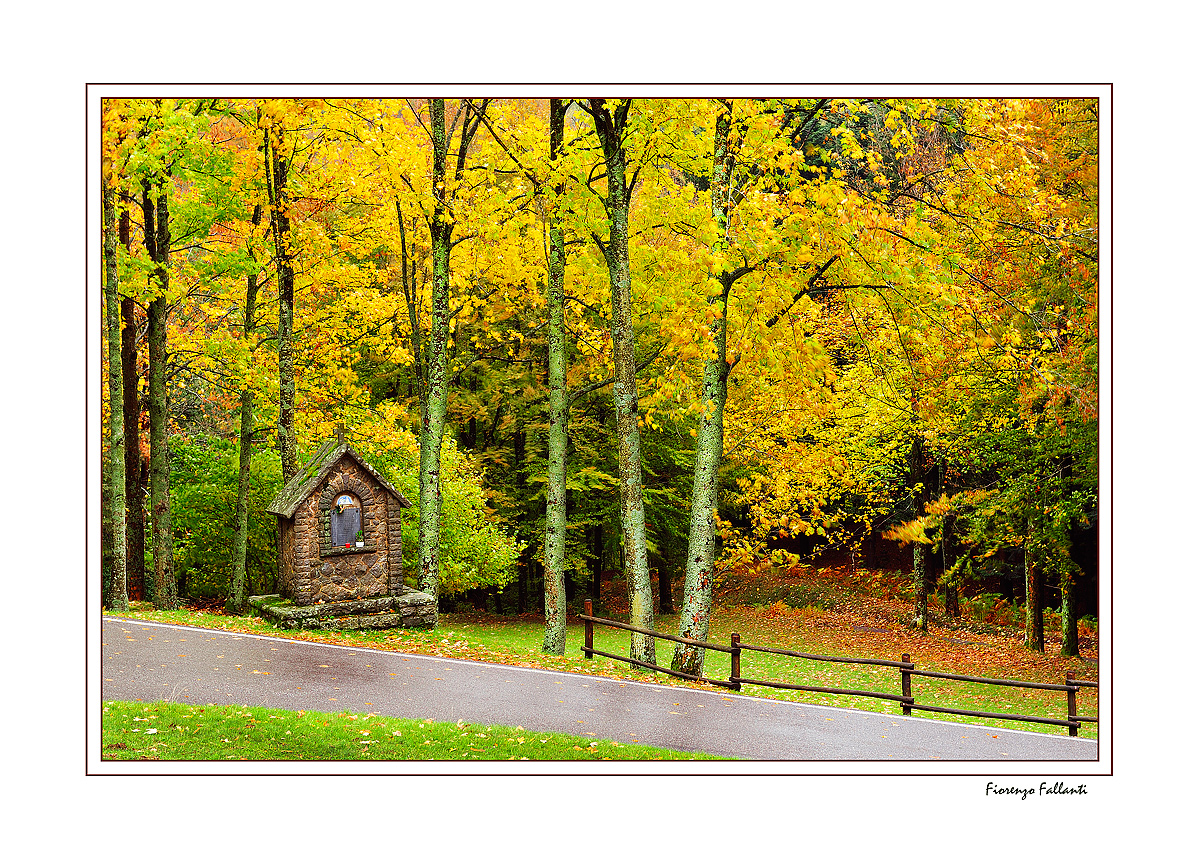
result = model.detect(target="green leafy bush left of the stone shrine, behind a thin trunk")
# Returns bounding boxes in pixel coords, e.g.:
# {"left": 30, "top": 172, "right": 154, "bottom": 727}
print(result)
{"left": 170, "top": 437, "right": 283, "bottom": 597}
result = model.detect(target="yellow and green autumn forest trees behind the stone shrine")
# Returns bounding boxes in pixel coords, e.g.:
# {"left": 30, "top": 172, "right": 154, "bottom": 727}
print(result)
{"left": 101, "top": 97, "right": 1102, "bottom": 673}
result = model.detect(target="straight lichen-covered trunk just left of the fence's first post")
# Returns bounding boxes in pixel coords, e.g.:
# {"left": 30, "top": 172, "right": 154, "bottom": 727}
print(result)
{"left": 541, "top": 98, "right": 570, "bottom": 656}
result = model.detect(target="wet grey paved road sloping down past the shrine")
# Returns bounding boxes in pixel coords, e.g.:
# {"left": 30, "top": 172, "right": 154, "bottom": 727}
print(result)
{"left": 102, "top": 618, "right": 1098, "bottom": 761}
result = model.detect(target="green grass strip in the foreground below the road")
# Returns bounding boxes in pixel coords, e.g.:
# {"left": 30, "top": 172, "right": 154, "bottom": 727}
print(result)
{"left": 101, "top": 701, "right": 721, "bottom": 761}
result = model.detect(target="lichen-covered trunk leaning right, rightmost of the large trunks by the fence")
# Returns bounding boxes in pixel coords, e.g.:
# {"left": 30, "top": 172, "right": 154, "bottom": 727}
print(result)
{"left": 671, "top": 102, "right": 733, "bottom": 675}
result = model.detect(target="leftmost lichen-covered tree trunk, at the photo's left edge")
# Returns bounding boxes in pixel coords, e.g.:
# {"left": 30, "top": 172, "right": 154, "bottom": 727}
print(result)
{"left": 102, "top": 179, "right": 130, "bottom": 612}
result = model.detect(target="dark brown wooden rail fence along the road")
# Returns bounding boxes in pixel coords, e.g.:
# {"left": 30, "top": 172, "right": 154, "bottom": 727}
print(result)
{"left": 580, "top": 600, "right": 1099, "bottom": 737}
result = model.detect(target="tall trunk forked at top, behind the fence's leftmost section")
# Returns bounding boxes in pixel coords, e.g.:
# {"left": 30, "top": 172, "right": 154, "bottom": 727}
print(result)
{"left": 592, "top": 98, "right": 655, "bottom": 665}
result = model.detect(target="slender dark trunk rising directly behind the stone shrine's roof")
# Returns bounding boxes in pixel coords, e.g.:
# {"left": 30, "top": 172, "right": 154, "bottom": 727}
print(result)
{"left": 263, "top": 126, "right": 300, "bottom": 482}
